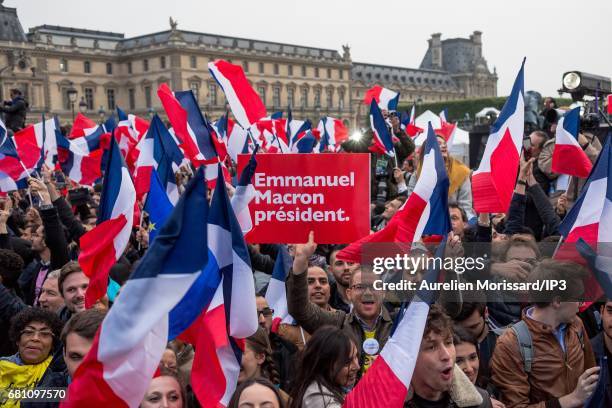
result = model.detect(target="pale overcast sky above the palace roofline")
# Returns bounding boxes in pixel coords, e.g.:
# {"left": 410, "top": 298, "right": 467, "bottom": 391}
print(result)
{"left": 9, "top": 0, "right": 612, "bottom": 96}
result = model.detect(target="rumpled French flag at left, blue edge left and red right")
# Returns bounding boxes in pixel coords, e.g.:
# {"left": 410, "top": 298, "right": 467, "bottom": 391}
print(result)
{"left": 57, "top": 127, "right": 111, "bottom": 185}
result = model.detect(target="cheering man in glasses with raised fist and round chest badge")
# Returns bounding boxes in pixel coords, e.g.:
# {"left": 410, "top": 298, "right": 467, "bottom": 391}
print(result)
{"left": 287, "top": 232, "right": 393, "bottom": 374}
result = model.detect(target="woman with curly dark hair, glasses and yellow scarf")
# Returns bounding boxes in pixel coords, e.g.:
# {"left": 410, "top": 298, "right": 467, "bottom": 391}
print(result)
{"left": 0, "top": 307, "right": 65, "bottom": 407}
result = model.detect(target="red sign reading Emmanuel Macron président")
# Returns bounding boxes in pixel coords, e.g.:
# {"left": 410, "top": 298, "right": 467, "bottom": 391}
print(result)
{"left": 238, "top": 153, "right": 370, "bottom": 244}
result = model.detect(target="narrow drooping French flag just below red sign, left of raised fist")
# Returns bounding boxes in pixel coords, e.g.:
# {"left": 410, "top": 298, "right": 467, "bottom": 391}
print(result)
{"left": 266, "top": 245, "right": 294, "bottom": 332}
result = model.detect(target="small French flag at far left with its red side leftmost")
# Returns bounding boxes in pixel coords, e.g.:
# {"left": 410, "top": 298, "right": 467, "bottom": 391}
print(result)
{"left": 13, "top": 117, "right": 61, "bottom": 169}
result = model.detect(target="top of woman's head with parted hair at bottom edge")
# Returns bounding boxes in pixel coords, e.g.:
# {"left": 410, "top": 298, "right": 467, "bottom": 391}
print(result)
{"left": 228, "top": 377, "right": 286, "bottom": 408}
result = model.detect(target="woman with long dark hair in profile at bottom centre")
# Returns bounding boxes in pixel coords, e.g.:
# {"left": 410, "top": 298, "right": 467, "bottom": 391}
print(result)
{"left": 290, "top": 326, "right": 359, "bottom": 408}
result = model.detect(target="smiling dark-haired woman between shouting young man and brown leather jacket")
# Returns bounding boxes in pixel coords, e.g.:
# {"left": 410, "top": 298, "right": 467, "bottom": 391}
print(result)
{"left": 453, "top": 325, "right": 505, "bottom": 408}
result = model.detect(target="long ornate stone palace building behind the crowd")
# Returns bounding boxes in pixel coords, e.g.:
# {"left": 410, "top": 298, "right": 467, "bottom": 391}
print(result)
{"left": 0, "top": 0, "right": 497, "bottom": 127}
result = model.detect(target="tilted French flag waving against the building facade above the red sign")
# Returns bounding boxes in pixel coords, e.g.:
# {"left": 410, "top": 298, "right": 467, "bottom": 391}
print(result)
{"left": 208, "top": 60, "right": 267, "bottom": 129}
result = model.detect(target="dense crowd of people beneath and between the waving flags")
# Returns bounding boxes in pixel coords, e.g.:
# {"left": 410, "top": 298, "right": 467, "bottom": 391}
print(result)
{"left": 0, "top": 93, "right": 612, "bottom": 408}
